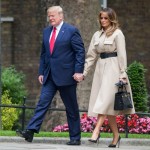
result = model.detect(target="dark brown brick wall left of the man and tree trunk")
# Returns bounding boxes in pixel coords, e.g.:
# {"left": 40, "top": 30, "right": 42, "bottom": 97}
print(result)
{"left": 1, "top": 0, "right": 46, "bottom": 99}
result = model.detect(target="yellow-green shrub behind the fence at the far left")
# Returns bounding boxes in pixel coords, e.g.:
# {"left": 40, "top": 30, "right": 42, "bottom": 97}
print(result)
{"left": 1, "top": 91, "right": 18, "bottom": 130}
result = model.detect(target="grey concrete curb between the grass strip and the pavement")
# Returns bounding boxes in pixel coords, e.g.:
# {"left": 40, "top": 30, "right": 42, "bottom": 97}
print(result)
{"left": 0, "top": 136, "right": 150, "bottom": 146}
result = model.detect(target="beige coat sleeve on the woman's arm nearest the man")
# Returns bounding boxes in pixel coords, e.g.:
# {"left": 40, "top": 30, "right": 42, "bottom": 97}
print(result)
{"left": 83, "top": 32, "right": 98, "bottom": 76}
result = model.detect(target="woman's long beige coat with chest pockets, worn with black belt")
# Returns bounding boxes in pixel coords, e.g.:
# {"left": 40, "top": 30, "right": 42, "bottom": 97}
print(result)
{"left": 84, "top": 29, "right": 135, "bottom": 116}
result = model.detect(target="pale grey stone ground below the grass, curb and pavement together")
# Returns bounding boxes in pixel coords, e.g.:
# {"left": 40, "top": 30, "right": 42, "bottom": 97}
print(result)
{"left": 0, "top": 136, "right": 150, "bottom": 150}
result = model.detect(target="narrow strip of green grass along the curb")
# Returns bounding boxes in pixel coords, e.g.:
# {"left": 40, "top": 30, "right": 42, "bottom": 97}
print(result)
{"left": 0, "top": 130, "right": 150, "bottom": 139}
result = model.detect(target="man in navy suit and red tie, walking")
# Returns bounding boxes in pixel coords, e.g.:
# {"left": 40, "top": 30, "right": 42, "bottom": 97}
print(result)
{"left": 17, "top": 6, "right": 85, "bottom": 145}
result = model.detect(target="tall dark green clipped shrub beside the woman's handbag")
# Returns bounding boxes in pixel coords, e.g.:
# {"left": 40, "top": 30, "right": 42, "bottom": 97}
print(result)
{"left": 127, "top": 61, "right": 148, "bottom": 112}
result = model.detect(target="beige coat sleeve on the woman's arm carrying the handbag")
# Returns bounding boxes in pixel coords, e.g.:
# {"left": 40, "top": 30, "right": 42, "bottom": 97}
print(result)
{"left": 115, "top": 31, "right": 127, "bottom": 78}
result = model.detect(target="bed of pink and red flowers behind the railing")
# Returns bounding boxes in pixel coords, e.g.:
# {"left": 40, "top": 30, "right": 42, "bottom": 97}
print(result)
{"left": 53, "top": 113, "right": 150, "bottom": 134}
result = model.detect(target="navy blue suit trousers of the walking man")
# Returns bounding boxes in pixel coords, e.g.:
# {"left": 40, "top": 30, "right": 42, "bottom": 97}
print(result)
{"left": 27, "top": 77, "right": 81, "bottom": 140}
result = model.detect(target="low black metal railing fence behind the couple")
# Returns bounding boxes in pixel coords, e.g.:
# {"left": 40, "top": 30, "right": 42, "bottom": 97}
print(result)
{"left": 0, "top": 97, "right": 150, "bottom": 138}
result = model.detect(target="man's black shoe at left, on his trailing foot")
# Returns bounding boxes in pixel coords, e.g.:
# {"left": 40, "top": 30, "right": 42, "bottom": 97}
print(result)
{"left": 16, "top": 130, "right": 34, "bottom": 142}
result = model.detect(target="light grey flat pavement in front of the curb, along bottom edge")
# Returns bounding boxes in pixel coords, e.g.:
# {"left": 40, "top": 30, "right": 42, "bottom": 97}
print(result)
{"left": 0, "top": 142, "right": 150, "bottom": 150}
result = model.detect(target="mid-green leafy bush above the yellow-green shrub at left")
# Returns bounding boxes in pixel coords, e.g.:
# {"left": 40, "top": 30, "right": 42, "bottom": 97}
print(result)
{"left": 2, "top": 66, "right": 27, "bottom": 104}
